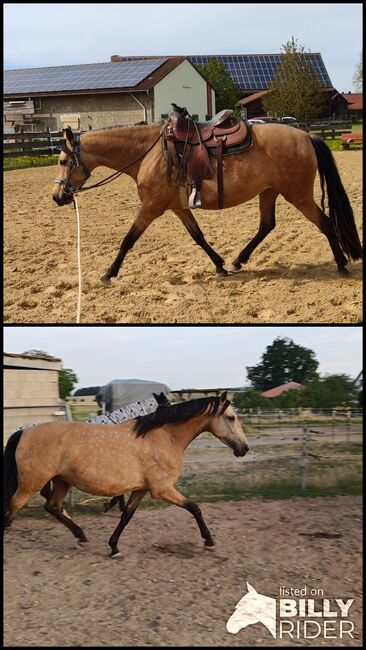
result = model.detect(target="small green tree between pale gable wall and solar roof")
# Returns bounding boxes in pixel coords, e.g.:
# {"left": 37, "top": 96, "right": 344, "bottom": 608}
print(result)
{"left": 196, "top": 59, "right": 242, "bottom": 115}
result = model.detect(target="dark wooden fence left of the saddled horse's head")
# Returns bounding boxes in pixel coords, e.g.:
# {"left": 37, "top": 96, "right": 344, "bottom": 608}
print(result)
{"left": 3, "top": 130, "right": 68, "bottom": 158}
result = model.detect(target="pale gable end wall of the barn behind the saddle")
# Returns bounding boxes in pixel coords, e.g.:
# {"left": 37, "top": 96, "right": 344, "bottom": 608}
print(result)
{"left": 154, "top": 61, "right": 216, "bottom": 122}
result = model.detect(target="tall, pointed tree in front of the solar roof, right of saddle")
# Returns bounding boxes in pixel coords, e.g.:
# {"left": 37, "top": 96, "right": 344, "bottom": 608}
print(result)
{"left": 263, "top": 36, "right": 326, "bottom": 123}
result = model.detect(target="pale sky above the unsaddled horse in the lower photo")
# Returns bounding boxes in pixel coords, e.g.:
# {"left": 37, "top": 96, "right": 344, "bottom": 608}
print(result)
{"left": 4, "top": 326, "right": 362, "bottom": 390}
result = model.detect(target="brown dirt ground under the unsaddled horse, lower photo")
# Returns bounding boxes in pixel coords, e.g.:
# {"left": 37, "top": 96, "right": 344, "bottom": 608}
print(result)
{"left": 4, "top": 497, "right": 362, "bottom": 646}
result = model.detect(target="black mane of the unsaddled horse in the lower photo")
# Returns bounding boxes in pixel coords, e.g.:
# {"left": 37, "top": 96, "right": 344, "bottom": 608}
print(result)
{"left": 135, "top": 397, "right": 230, "bottom": 438}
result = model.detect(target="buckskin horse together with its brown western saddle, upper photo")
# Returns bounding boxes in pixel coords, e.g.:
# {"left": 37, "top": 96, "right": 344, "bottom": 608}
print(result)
{"left": 53, "top": 104, "right": 362, "bottom": 284}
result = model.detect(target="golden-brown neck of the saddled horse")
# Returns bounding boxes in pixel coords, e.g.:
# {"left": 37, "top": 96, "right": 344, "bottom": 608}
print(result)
{"left": 81, "top": 125, "right": 160, "bottom": 178}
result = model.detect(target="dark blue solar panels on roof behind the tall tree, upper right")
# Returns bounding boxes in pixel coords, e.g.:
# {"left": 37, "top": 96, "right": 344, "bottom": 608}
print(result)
{"left": 188, "top": 52, "right": 332, "bottom": 90}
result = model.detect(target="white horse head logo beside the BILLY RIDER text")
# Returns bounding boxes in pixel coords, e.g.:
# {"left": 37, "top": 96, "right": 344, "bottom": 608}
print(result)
{"left": 226, "top": 582, "right": 276, "bottom": 638}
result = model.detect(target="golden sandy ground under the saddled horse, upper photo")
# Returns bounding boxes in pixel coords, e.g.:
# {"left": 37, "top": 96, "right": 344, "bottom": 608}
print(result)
{"left": 4, "top": 151, "right": 362, "bottom": 323}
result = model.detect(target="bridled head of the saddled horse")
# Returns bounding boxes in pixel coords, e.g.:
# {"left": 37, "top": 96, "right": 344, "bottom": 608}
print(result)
{"left": 52, "top": 126, "right": 90, "bottom": 205}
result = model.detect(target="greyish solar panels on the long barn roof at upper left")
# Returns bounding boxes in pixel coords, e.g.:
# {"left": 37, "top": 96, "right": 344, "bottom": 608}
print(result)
{"left": 4, "top": 59, "right": 166, "bottom": 95}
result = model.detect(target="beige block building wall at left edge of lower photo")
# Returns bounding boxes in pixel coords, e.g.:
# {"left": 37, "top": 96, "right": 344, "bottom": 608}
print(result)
{"left": 4, "top": 355, "right": 62, "bottom": 443}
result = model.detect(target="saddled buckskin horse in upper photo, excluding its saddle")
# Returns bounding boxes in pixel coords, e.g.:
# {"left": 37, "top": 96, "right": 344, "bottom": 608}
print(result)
{"left": 53, "top": 116, "right": 362, "bottom": 284}
